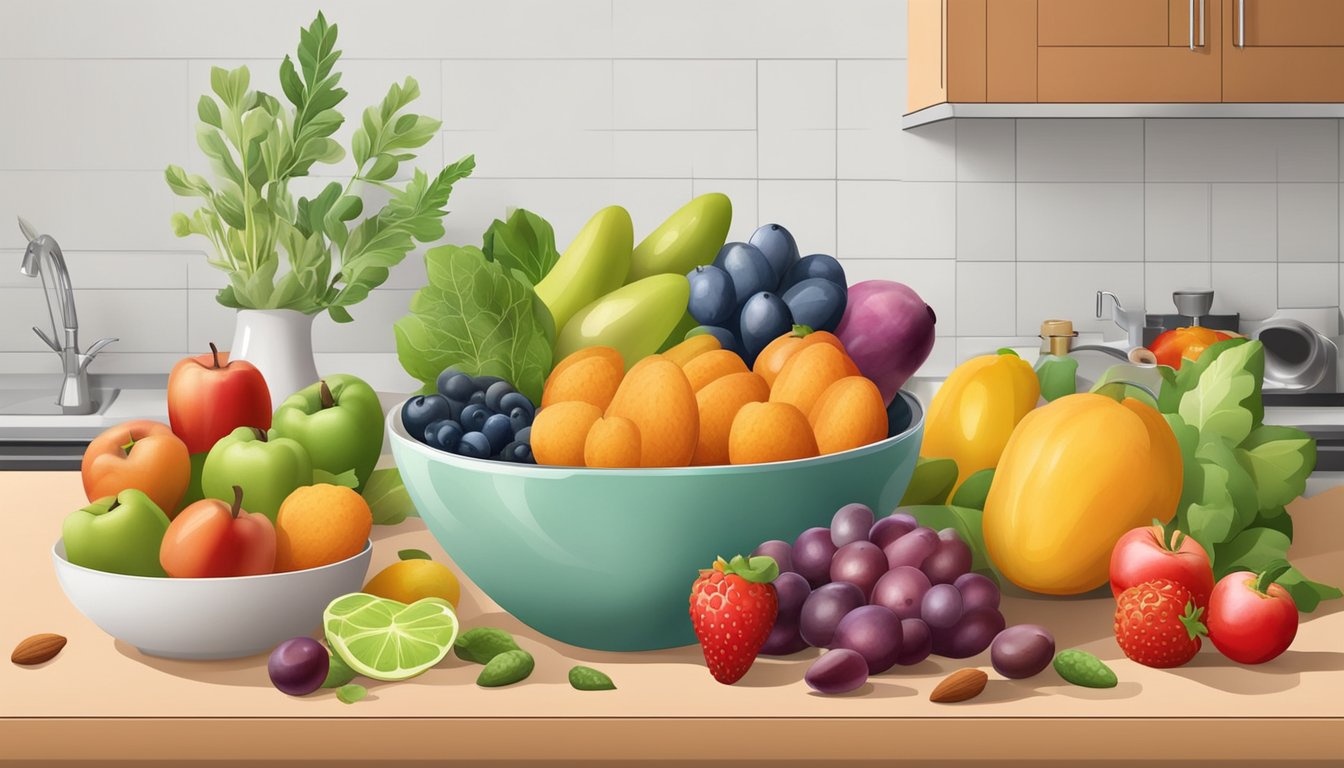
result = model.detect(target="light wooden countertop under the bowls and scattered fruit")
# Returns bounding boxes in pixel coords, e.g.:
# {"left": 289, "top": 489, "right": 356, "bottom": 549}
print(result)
{"left": 0, "top": 472, "right": 1344, "bottom": 764}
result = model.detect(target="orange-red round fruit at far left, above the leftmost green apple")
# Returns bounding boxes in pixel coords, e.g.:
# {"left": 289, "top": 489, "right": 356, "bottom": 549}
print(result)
{"left": 79, "top": 418, "right": 191, "bottom": 518}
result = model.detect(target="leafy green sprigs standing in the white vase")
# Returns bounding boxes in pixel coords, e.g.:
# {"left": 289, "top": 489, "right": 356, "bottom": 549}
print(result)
{"left": 164, "top": 13, "right": 476, "bottom": 323}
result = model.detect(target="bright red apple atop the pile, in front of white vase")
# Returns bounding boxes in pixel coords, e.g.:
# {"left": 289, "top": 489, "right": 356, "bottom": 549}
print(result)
{"left": 168, "top": 344, "right": 270, "bottom": 455}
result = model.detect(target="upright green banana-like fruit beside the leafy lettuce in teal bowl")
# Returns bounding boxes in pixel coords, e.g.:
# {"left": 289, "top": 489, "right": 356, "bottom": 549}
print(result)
{"left": 536, "top": 206, "right": 634, "bottom": 328}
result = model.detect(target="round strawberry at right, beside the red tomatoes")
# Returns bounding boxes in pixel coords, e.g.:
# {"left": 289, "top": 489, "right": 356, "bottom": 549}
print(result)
{"left": 1116, "top": 578, "right": 1206, "bottom": 668}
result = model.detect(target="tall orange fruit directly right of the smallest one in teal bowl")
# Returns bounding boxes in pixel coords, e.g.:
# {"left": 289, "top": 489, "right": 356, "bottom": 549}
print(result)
{"left": 604, "top": 352, "right": 698, "bottom": 467}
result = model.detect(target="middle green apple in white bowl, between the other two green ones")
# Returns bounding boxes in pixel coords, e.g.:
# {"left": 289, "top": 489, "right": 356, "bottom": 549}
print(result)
{"left": 200, "top": 426, "right": 313, "bottom": 522}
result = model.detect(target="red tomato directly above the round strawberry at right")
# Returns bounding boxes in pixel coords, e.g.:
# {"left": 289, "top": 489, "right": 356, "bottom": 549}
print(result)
{"left": 1110, "top": 526, "right": 1214, "bottom": 608}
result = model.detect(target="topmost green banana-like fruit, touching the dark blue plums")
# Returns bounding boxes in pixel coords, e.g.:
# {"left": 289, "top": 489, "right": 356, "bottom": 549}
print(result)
{"left": 626, "top": 192, "right": 732, "bottom": 282}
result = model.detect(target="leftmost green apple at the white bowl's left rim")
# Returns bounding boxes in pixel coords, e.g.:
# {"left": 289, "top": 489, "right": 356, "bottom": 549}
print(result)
{"left": 60, "top": 488, "right": 168, "bottom": 576}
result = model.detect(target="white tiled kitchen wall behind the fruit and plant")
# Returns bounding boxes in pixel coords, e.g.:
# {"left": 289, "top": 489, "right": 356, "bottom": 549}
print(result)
{"left": 0, "top": 0, "right": 1344, "bottom": 389}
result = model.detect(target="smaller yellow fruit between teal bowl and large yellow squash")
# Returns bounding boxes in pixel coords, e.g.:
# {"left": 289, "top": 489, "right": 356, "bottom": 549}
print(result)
{"left": 919, "top": 352, "right": 1040, "bottom": 490}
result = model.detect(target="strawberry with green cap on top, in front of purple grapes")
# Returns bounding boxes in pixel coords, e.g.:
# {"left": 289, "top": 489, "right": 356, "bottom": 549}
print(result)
{"left": 691, "top": 555, "right": 780, "bottom": 685}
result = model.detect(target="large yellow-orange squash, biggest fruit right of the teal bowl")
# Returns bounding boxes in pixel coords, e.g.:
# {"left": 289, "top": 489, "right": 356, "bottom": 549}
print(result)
{"left": 984, "top": 394, "right": 1181, "bottom": 594}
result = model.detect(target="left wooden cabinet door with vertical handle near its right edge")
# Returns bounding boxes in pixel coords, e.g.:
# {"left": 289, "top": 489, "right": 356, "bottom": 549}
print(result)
{"left": 1036, "top": 0, "right": 1222, "bottom": 104}
